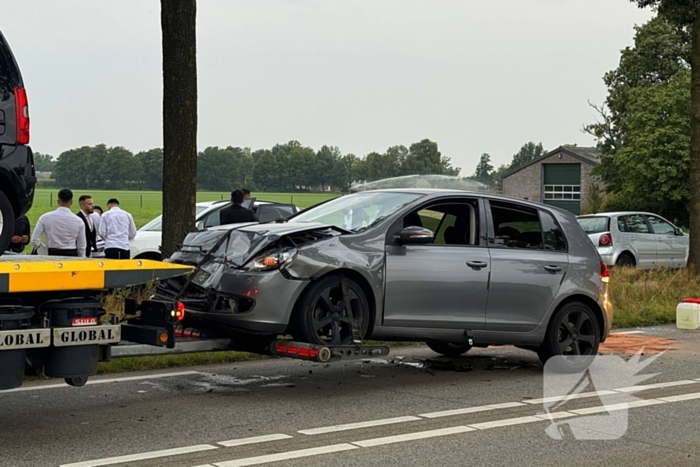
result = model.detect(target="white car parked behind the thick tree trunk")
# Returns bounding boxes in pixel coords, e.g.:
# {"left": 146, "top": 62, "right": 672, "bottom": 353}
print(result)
{"left": 130, "top": 200, "right": 299, "bottom": 261}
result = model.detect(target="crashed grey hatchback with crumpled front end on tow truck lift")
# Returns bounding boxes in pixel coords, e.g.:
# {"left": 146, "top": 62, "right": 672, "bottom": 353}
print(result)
{"left": 157, "top": 189, "right": 612, "bottom": 369}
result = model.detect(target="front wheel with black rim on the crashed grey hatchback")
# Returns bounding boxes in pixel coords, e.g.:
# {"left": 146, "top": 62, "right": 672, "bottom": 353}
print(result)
{"left": 291, "top": 274, "right": 370, "bottom": 345}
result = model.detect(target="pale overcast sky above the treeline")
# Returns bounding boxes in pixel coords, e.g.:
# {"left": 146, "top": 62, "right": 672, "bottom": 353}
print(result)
{"left": 0, "top": 0, "right": 652, "bottom": 175}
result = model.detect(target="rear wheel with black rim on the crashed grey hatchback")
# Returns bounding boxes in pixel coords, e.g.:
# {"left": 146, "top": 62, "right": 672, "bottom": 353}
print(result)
{"left": 537, "top": 302, "right": 600, "bottom": 373}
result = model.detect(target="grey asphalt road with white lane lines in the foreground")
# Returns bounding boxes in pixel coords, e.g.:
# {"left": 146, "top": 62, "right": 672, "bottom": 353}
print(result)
{"left": 0, "top": 326, "right": 700, "bottom": 467}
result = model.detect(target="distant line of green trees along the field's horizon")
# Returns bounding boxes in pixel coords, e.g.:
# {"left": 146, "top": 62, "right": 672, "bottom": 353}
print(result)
{"left": 35, "top": 139, "right": 460, "bottom": 192}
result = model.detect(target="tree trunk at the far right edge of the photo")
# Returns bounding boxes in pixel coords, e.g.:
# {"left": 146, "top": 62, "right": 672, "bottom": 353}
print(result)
{"left": 688, "top": 13, "right": 700, "bottom": 274}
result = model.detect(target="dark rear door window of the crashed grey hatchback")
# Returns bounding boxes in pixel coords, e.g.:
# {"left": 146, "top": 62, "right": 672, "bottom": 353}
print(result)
{"left": 489, "top": 201, "right": 544, "bottom": 250}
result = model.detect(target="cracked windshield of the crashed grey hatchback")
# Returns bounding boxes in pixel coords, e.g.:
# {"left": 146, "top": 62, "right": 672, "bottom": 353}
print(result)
{"left": 292, "top": 191, "right": 423, "bottom": 232}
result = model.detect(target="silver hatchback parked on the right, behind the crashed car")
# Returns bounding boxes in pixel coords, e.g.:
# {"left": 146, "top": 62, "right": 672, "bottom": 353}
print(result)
{"left": 578, "top": 212, "right": 689, "bottom": 269}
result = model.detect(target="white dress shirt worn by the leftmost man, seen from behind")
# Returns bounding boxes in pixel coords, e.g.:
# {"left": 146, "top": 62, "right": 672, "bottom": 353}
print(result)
{"left": 32, "top": 206, "right": 87, "bottom": 256}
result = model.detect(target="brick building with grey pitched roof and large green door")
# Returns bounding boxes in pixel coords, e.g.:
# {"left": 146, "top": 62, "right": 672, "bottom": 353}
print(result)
{"left": 503, "top": 146, "right": 600, "bottom": 214}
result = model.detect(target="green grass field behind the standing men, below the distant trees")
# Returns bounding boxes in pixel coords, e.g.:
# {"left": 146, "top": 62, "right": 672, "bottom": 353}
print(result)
{"left": 27, "top": 188, "right": 338, "bottom": 228}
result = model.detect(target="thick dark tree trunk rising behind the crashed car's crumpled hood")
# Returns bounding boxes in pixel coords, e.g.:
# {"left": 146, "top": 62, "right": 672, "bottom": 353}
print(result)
{"left": 161, "top": 0, "right": 197, "bottom": 255}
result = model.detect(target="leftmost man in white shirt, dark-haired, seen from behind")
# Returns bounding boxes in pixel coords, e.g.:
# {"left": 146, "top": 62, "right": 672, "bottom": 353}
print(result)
{"left": 32, "top": 188, "right": 87, "bottom": 257}
